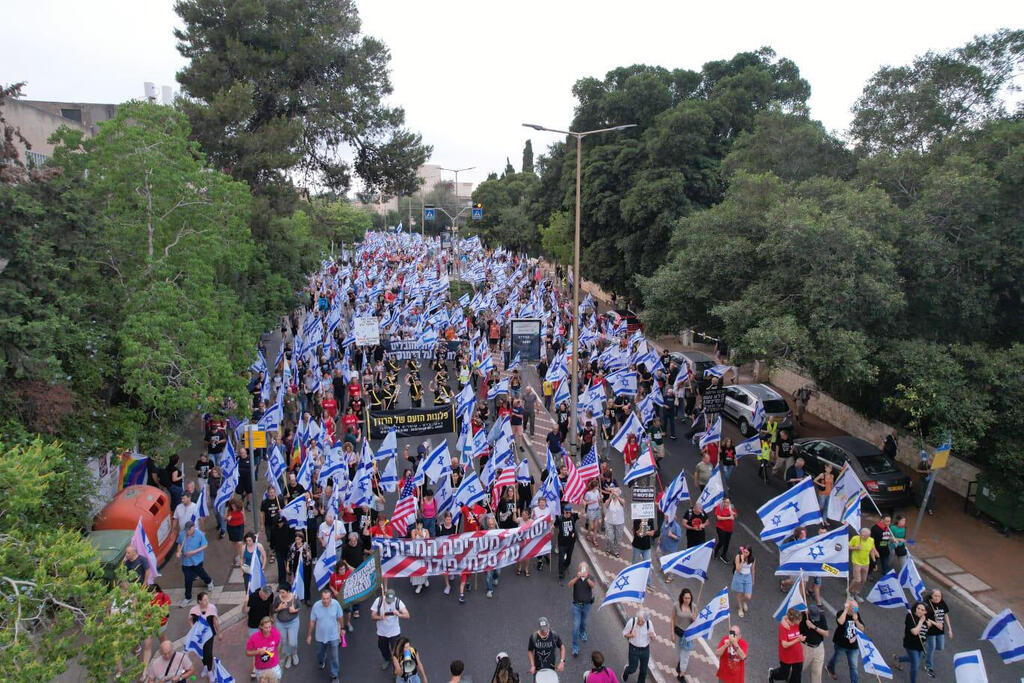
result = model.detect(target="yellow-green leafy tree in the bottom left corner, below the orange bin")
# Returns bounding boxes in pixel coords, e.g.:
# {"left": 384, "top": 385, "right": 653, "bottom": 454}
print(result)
{"left": 0, "top": 440, "right": 160, "bottom": 683}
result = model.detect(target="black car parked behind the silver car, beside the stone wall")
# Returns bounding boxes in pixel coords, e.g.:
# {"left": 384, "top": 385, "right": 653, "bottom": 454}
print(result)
{"left": 794, "top": 436, "right": 911, "bottom": 510}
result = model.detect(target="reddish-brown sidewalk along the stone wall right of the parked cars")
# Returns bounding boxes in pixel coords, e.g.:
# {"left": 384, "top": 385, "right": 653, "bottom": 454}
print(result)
{"left": 582, "top": 274, "right": 1024, "bottom": 618}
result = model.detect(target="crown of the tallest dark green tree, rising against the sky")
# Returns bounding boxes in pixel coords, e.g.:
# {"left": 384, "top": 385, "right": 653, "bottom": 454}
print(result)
{"left": 174, "top": 0, "right": 430, "bottom": 195}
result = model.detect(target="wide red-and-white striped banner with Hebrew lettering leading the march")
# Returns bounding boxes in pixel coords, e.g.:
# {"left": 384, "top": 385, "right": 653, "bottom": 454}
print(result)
{"left": 373, "top": 518, "right": 551, "bottom": 579}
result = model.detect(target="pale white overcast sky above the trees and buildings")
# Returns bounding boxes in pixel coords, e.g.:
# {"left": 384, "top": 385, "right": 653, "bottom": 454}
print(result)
{"left": 0, "top": 0, "right": 1024, "bottom": 191}
